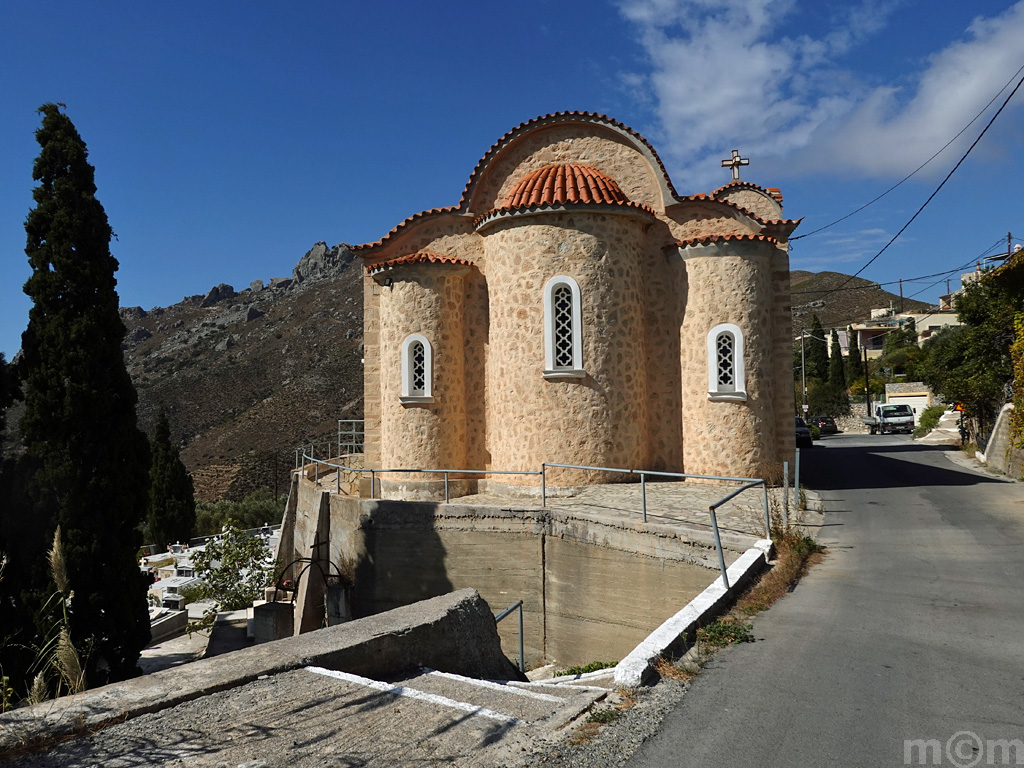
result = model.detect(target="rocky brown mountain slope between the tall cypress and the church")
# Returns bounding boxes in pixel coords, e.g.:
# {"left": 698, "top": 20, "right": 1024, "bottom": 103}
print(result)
{"left": 121, "top": 243, "right": 362, "bottom": 499}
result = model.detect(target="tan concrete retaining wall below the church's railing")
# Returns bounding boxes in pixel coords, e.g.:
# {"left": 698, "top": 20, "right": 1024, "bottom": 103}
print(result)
{"left": 282, "top": 482, "right": 754, "bottom": 665}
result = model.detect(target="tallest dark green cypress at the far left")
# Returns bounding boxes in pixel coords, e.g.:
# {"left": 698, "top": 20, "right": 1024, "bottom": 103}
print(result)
{"left": 20, "top": 103, "right": 150, "bottom": 686}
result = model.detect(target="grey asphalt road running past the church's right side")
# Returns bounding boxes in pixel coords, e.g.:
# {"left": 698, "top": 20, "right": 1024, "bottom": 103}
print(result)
{"left": 629, "top": 435, "right": 1024, "bottom": 768}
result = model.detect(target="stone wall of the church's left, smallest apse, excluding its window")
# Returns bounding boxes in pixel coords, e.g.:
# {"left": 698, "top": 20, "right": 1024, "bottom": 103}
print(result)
{"left": 380, "top": 264, "right": 466, "bottom": 493}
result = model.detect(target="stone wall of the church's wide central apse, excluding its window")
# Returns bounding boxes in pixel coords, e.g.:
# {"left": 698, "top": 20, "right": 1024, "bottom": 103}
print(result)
{"left": 486, "top": 212, "right": 647, "bottom": 485}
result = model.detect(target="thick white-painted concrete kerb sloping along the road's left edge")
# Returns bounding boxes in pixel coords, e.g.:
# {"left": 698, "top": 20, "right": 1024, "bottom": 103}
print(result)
{"left": 615, "top": 539, "right": 772, "bottom": 688}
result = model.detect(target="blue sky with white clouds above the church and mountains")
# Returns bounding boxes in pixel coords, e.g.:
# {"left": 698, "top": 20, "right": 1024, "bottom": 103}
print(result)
{"left": 0, "top": 0, "right": 1024, "bottom": 359}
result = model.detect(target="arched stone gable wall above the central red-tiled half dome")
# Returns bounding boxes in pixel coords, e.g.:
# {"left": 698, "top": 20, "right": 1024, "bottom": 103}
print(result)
{"left": 472, "top": 124, "right": 664, "bottom": 213}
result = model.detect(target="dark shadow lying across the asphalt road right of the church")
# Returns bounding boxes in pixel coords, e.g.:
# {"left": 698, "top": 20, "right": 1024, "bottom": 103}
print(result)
{"left": 801, "top": 441, "right": 1000, "bottom": 490}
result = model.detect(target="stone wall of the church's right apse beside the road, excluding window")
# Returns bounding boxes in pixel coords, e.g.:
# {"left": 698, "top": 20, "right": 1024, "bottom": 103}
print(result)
{"left": 680, "top": 243, "right": 776, "bottom": 477}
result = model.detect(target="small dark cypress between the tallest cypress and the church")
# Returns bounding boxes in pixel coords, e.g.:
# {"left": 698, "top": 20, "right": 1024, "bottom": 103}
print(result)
{"left": 145, "top": 406, "right": 196, "bottom": 552}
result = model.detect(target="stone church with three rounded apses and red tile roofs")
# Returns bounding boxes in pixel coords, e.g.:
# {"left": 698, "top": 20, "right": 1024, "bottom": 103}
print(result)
{"left": 352, "top": 112, "right": 799, "bottom": 499}
